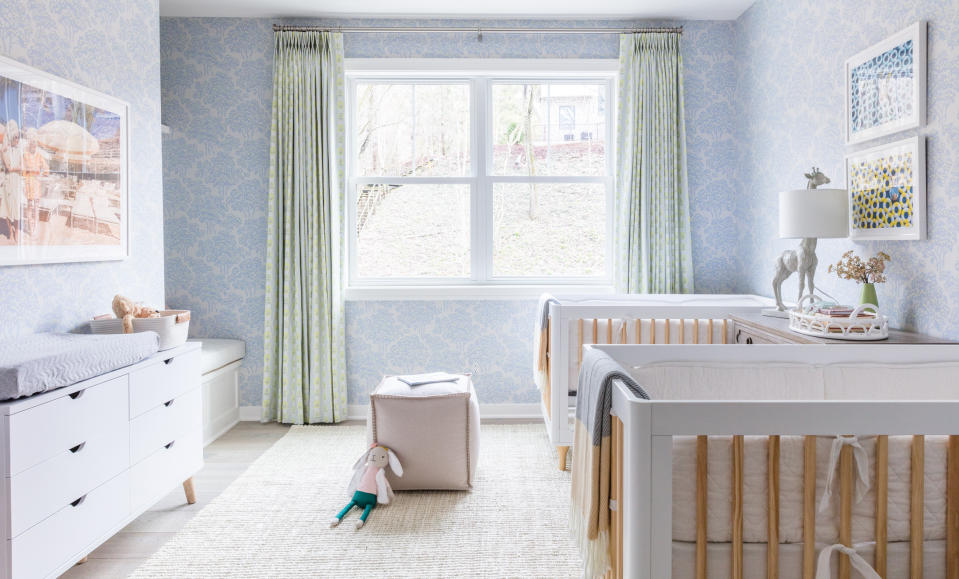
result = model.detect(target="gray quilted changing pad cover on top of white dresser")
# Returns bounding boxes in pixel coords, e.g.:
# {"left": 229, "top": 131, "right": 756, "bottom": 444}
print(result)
{"left": 0, "top": 332, "right": 160, "bottom": 400}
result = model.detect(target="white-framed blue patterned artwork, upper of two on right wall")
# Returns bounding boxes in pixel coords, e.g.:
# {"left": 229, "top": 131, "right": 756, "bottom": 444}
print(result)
{"left": 845, "top": 21, "right": 926, "bottom": 145}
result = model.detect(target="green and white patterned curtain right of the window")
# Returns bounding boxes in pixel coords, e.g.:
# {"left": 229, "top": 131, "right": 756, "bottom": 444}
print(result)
{"left": 615, "top": 33, "right": 693, "bottom": 293}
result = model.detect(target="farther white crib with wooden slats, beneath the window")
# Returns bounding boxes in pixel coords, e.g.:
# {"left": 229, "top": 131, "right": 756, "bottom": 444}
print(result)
{"left": 541, "top": 294, "right": 775, "bottom": 469}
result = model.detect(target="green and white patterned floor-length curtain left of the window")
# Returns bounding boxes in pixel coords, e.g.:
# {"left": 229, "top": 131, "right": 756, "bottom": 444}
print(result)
{"left": 262, "top": 31, "right": 346, "bottom": 424}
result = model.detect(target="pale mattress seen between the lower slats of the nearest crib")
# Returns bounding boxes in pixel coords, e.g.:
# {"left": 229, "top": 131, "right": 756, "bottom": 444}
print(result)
{"left": 673, "top": 540, "right": 946, "bottom": 579}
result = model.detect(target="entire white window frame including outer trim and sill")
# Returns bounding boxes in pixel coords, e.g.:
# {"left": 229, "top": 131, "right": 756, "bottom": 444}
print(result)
{"left": 344, "top": 59, "right": 618, "bottom": 299}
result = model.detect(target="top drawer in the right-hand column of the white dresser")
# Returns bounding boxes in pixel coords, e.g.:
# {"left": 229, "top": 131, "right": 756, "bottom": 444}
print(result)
{"left": 130, "top": 351, "right": 200, "bottom": 418}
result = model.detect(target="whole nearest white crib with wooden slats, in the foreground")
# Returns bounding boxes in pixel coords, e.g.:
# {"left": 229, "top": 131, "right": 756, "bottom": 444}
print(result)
{"left": 600, "top": 344, "right": 959, "bottom": 579}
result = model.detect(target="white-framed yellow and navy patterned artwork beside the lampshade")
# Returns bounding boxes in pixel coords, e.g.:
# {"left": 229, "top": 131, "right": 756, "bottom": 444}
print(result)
{"left": 846, "top": 137, "right": 926, "bottom": 240}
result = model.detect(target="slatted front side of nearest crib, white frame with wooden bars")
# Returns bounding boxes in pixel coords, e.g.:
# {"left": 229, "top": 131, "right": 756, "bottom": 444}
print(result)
{"left": 609, "top": 384, "right": 959, "bottom": 579}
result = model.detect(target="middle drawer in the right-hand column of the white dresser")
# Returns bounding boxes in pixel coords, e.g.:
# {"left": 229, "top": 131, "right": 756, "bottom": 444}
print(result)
{"left": 130, "top": 388, "right": 203, "bottom": 464}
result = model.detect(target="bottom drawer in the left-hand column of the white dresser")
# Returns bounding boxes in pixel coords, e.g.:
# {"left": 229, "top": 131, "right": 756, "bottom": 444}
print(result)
{"left": 10, "top": 473, "right": 130, "bottom": 577}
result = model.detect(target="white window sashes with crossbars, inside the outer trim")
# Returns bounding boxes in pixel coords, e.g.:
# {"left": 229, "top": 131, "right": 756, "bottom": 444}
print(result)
{"left": 344, "top": 69, "right": 616, "bottom": 288}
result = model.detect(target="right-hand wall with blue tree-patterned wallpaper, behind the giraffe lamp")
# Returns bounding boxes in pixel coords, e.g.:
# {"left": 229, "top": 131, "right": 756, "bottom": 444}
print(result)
{"left": 734, "top": 0, "right": 959, "bottom": 339}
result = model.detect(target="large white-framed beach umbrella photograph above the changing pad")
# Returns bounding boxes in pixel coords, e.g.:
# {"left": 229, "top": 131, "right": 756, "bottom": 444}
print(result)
{"left": 0, "top": 57, "right": 130, "bottom": 265}
